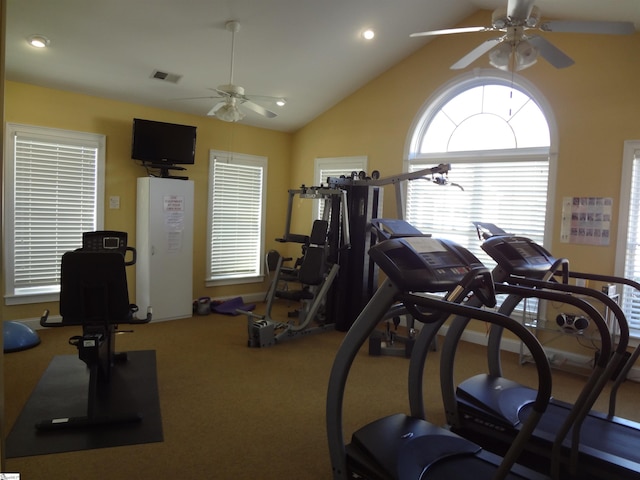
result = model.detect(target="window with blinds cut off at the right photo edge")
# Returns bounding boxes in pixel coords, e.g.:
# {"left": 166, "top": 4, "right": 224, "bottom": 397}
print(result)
{"left": 616, "top": 141, "right": 640, "bottom": 338}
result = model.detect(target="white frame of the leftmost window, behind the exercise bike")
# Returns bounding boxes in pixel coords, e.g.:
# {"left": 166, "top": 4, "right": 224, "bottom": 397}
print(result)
{"left": 3, "top": 123, "right": 106, "bottom": 305}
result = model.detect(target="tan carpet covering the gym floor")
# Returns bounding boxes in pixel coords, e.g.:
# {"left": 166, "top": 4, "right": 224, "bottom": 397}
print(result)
{"left": 5, "top": 306, "right": 640, "bottom": 480}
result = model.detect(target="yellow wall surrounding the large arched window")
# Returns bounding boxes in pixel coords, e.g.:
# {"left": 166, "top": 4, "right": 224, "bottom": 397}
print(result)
{"left": 293, "top": 12, "right": 640, "bottom": 274}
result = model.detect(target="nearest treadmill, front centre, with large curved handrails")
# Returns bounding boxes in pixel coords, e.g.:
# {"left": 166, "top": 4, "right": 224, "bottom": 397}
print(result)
{"left": 326, "top": 237, "right": 551, "bottom": 480}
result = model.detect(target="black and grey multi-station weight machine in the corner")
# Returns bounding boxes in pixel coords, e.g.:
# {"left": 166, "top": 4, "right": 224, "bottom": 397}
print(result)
{"left": 242, "top": 164, "right": 455, "bottom": 347}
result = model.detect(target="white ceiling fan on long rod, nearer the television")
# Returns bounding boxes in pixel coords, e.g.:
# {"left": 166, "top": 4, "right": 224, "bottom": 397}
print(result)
{"left": 188, "top": 20, "right": 286, "bottom": 122}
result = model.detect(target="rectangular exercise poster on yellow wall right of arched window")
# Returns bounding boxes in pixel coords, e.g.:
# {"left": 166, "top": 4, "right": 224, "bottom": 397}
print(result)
{"left": 560, "top": 197, "right": 613, "bottom": 245}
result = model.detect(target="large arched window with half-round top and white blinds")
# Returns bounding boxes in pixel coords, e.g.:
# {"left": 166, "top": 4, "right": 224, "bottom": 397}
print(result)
{"left": 405, "top": 70, "right": 555, "bottom": 263}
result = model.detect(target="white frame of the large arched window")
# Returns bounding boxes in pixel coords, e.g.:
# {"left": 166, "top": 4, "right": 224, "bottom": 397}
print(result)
{"left": 403, "top": 69, "right": 558, "bottom": 248}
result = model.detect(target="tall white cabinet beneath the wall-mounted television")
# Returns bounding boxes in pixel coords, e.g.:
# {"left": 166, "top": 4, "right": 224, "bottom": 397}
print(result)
{"left": 135, "top": 177, "right": 193, "bottom": 320}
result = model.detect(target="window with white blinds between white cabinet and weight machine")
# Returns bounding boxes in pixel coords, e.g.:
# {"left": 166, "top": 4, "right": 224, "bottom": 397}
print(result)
{"left": 207, "top": 151, "right": 267, "bottom": 285}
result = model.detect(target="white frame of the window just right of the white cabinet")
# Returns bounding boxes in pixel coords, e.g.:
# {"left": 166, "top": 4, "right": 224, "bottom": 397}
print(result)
{"left": 205, "top": 150, "right": 268, "bottom": 287}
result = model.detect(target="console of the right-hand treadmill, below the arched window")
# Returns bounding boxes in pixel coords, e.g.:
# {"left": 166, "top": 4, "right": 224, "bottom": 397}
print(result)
{"left": 482, "top": 235, "right": 560, "bottom": 277}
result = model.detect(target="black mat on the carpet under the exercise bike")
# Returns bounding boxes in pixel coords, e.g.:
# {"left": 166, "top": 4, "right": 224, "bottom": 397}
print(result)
{"left": 5, "top": 350, "right": 163, "bottom": 458}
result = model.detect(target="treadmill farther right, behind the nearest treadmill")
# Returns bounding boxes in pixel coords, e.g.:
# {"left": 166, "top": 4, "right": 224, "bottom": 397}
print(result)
{"left": 441, "top": 235, "right": 640, "bottom": 479}
